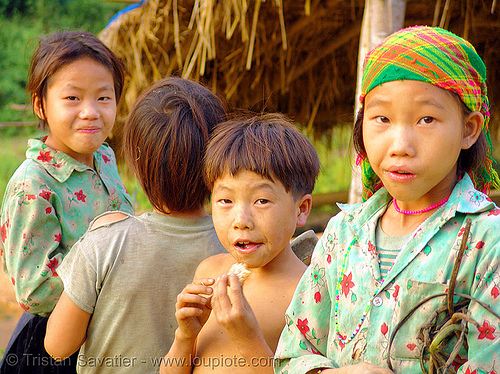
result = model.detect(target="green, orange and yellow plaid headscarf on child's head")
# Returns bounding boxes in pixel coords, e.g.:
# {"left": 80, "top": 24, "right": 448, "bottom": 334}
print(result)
{"left": 359, "top": 26, "right": 500, "bottom": 200}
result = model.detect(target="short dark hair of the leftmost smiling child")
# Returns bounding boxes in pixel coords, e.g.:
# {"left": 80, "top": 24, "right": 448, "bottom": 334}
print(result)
{"left": 26, "top": 31, "right": 124, "bottom": 129}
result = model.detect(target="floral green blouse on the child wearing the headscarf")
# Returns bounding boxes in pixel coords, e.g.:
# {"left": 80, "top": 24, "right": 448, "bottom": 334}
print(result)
{"left": 275, "top": 176, "right": 500, "bottom": 374}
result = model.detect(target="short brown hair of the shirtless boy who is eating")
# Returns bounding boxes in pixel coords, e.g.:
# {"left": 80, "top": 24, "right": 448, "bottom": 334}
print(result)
{"left": 204, "top": 113, "right": 320, "bottom": 198}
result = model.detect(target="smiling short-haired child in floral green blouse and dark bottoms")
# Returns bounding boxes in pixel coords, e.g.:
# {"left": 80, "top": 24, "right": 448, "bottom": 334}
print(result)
{"left": 0, "top": 31, "right": 133, "bottom": 374}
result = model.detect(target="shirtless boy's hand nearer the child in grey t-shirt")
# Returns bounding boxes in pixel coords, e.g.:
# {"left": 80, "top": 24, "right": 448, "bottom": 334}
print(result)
{"left": 175, "top": 278, "right": 215, "bottom": 340}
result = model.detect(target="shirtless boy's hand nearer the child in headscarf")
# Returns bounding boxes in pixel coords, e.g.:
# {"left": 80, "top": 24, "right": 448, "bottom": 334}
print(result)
{"left": 212, "top": 274, "right": 262, "bottom": 346}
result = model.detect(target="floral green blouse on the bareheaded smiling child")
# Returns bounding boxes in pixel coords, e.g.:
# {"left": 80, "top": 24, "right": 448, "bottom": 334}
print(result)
{"left": 0, "top": 139, "right": 133, "bottom": 316}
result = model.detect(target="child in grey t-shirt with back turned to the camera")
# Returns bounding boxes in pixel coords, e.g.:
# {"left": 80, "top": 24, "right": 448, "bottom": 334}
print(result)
{"left": 45, "top": 78, "right": 226, "bottom": 374}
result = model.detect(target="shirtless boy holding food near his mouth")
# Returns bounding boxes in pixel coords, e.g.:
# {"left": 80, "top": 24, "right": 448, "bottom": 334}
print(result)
{"left": 160, "top": 114, "right": 319, "bottom": 373}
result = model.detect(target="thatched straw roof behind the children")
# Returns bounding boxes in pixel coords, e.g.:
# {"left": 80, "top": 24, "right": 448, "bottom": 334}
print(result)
{"left": 101, "top": 0, "right": 500, "bottom": 144}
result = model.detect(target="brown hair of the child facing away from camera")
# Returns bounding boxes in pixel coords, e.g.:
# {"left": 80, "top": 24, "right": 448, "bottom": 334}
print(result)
{"left": 123, "top": 77, "right": 227, "bottom": 213}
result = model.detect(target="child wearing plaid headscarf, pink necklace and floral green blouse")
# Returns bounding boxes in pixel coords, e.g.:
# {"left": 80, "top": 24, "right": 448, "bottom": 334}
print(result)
{"left": 275, "top": 26, "right": 500, "bottom": 374}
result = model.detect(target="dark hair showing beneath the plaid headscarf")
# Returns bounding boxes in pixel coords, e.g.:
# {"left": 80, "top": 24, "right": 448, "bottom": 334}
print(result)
{"left": 352, "top": 91, "right": 488, "bottom": 178}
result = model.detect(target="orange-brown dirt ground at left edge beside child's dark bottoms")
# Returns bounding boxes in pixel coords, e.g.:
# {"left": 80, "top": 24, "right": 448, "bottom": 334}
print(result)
{"left": 0, "top": 269, "right": 22, "bottom": 356}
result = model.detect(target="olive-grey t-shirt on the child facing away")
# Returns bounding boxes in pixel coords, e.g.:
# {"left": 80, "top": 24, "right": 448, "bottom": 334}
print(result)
{"left": 57, "top": 212, "right": 225, "bottom": 374}
